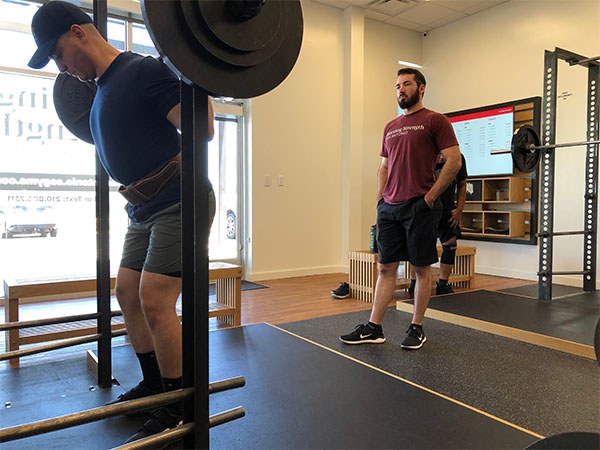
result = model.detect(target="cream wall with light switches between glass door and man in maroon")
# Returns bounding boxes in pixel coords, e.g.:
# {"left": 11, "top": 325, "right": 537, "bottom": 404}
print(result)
{"left": 246, "top": 0, "right": 421, "bottom": 280}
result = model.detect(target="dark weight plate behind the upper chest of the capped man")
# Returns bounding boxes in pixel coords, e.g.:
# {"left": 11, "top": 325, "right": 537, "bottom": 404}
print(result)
{"left": 53, "top": 73, "right": 96, "bottom": 144}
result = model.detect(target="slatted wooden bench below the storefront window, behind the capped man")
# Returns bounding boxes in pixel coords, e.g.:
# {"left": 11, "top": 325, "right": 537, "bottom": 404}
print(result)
{"left": 4, "top": 262, "right": 242, "bottom": 367}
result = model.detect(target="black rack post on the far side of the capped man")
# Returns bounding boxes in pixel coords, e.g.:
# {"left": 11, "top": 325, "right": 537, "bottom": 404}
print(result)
{"left": 94, "top": 0, "right": 112, "bottom": 388}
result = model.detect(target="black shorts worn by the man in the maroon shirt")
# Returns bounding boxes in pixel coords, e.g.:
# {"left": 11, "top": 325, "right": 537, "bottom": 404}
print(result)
{"left": 377, "top": 197, "right": 442, "bottom": 267}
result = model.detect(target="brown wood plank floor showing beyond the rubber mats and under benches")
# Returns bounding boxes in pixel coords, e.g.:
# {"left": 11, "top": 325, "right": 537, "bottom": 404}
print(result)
{"left": 0, "top": 273, "right": 535, "bottom": 370}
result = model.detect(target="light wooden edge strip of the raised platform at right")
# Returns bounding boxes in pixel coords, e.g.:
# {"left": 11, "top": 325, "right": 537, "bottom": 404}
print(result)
{"left": 396, "top": 301, "right": 596, "bottom": 360}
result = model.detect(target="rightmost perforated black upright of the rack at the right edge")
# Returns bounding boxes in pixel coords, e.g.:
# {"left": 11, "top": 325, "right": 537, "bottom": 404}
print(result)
{"left": 583, "top": 62, "right": 600, "bottom": 292}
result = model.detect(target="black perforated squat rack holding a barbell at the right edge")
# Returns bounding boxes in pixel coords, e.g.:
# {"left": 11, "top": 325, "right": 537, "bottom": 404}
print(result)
{"left": 538, "top": 48, "right": 600, "bottom": 300}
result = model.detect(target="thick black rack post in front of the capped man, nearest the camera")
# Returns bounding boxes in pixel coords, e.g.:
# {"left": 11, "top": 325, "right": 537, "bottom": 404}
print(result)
{"left": 181, "top": 81, "right": 209, "bottom": 449}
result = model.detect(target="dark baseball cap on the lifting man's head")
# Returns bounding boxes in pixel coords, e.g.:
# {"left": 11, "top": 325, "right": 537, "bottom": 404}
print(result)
{"left": 27, "top": 1, "right": 93, "bottom": 69}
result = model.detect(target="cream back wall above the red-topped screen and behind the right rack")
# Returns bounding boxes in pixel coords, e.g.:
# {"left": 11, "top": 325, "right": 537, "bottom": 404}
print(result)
{"left": 423, "top": 0, "right": 600, "bottom": 285}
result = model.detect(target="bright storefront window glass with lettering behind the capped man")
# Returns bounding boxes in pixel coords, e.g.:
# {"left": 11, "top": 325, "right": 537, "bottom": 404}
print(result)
{"left": 0, "top": 0, "right": 241, "bottom": 297}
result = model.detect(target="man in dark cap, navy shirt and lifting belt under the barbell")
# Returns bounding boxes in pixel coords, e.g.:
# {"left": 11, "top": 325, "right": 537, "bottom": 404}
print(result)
{"left": 29, "top": 1, "right": 214, "bottom": 442}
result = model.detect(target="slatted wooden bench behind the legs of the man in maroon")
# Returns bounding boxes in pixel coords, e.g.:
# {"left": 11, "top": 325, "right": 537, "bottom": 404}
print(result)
{"left": 348, "top": 245, "right": 477, "bottom": 303}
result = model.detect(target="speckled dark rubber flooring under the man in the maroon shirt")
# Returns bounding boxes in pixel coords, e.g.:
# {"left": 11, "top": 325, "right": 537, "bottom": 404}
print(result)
{"left": 282, "top": 308, "right": 600, "bottom": 438}
